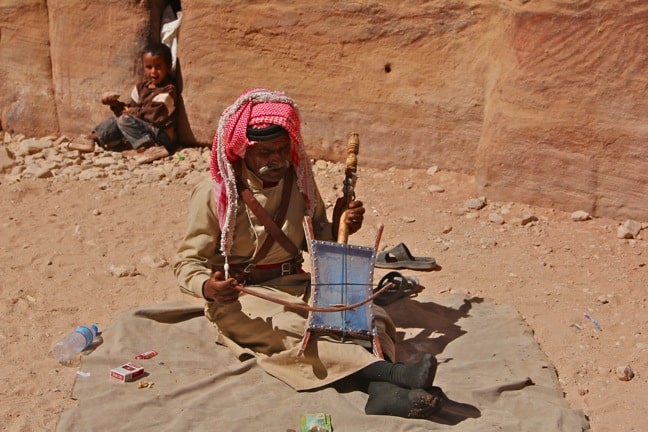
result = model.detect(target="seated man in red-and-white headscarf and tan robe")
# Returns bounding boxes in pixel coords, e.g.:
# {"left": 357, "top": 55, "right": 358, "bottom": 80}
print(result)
{"left": 174, "top": 89, "right": 444, "bottom": 418}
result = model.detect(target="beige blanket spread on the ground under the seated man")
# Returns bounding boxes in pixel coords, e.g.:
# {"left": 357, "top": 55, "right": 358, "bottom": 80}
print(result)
{"left": 57, "top": 296, "right": 589, "bottom": 432}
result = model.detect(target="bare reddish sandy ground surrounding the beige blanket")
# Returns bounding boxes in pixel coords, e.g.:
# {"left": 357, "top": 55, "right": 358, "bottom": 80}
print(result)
{"left": 0, "top": 149, "right": 648, "bottom": 432}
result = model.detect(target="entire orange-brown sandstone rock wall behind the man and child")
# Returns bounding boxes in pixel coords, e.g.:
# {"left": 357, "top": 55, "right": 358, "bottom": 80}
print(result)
{"left": 0, "top": 0, "right": 648, "bottom": 220}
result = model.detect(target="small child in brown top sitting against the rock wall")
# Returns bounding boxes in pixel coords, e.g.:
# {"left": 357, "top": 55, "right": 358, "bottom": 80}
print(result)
{"left": 68, "top": 43, "right": 177, "bottom": 163}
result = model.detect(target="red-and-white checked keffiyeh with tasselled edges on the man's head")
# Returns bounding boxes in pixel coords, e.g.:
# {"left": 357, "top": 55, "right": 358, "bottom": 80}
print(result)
{"left": 211, "top": 89, "right": 314, "bottom": 259}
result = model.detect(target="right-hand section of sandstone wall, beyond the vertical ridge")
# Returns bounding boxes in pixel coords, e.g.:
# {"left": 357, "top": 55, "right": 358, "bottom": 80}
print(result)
{"left": 475, "top": 1, "right": 648, "bottom": 220}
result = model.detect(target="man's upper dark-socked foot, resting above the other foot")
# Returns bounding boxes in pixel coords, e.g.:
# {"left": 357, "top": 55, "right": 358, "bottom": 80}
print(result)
{"left": 360, "top": 354, "right": 437, "bottom": 389}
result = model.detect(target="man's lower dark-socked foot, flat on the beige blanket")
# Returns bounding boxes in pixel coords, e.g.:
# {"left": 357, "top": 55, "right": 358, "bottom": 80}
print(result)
{"left": 365, "top": 381, "right": 445, "bottom": 419}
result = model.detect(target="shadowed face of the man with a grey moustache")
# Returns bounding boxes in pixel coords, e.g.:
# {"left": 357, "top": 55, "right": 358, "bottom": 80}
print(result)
{"left": 245, "top": 133, "right": 292, "bottom": 183}
